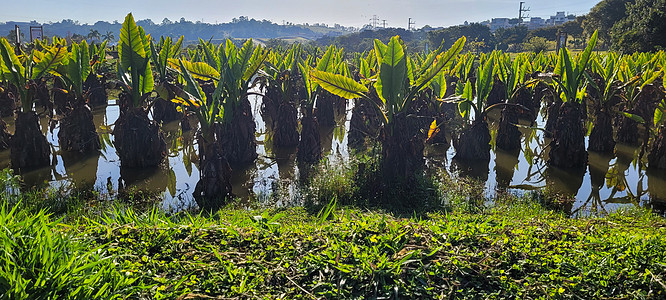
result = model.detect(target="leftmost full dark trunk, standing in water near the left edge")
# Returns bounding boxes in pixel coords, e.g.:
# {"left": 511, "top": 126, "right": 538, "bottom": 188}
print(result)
{"left": 10, "top": 111, "right": 51, "bottom": 169}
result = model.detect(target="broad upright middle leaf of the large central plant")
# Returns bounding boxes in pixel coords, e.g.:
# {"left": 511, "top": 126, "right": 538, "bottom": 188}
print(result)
{"left": 375, "top": 36, "right": 407, "bottom": 110}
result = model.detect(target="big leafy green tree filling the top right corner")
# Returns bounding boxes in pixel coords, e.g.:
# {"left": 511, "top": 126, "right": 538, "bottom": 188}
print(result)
{"left": 611, "top": 0, "right": 666, "bottom": 52}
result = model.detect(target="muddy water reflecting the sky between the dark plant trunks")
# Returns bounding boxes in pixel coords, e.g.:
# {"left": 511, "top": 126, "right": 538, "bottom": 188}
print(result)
{"left": 0, "top": 96, "right": 666, "bottom": 214}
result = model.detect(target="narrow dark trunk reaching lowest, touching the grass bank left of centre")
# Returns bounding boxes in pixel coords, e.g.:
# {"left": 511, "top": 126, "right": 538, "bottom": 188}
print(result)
{"left": 193, "top": 130, "right": 233, "bottom": 210}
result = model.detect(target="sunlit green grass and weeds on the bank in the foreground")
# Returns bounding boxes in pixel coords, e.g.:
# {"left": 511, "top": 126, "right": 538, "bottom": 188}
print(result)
{"left": 0, "top": 167, "right": 666, "bottom": 299}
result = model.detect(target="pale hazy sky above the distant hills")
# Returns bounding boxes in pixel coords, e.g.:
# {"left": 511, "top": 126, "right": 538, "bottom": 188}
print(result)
{"left": 0, "top": 0, "right": 600, "bottom": 28}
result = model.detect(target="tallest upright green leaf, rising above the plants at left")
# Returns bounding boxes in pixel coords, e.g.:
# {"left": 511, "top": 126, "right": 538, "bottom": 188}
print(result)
{"left": 118, "top": 13, "right": 146, "bottom": 70}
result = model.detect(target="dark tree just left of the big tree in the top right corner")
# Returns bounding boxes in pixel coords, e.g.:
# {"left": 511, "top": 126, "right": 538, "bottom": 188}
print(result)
{"left": 581, "top": 0, "right": 635, "bottom": 43}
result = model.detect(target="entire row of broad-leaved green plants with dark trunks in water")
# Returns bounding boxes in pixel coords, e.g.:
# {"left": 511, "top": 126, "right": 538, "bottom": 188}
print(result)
{"left": 0, "top": 14, "right": 666, "bottom": 207}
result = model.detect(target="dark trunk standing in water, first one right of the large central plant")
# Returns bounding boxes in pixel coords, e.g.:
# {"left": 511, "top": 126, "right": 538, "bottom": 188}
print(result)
{"left": 453, "top": 117, "right": 491, "bottom": 161}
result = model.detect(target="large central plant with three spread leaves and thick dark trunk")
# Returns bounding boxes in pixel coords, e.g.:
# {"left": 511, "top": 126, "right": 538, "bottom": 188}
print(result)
{"left": 309, "top": 36, "right": 465, "bottom": 178}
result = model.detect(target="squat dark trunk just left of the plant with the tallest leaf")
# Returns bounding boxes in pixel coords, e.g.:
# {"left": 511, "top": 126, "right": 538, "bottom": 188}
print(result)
{"left": 58, "top": 103, "right": 102, "bottom": 153}
